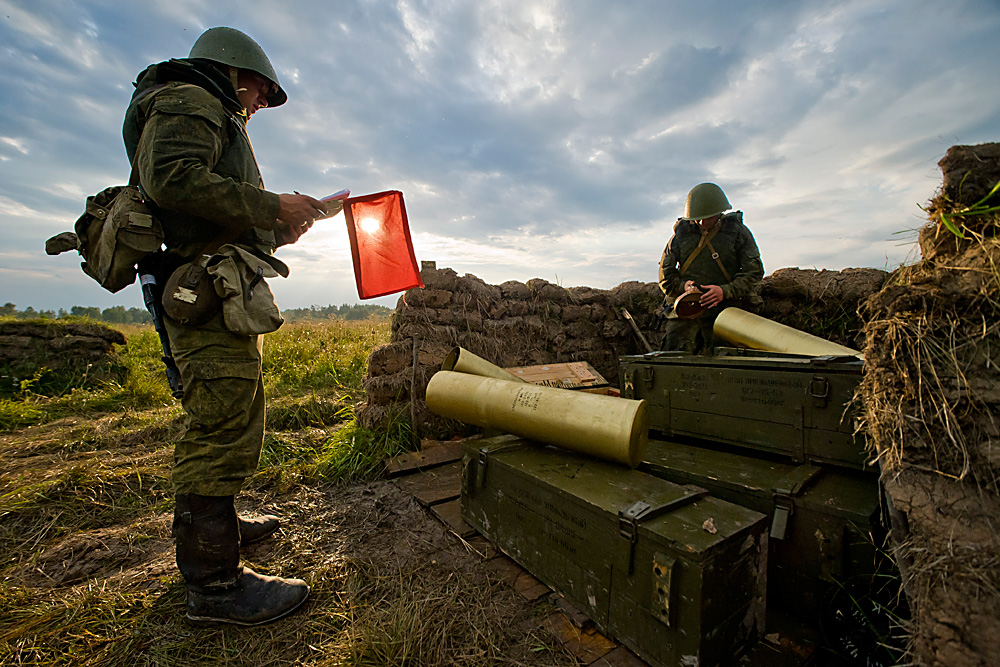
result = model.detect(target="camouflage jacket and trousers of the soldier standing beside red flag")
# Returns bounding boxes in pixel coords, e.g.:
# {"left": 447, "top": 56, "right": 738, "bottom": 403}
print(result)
{"left": 123, "top": 60, "right": 280, "bottom": 496}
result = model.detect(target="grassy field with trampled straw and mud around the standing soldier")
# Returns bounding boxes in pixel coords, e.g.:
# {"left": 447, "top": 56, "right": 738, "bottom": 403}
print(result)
{"left": 0, "top": 319, "right": 576, "bottom": 666}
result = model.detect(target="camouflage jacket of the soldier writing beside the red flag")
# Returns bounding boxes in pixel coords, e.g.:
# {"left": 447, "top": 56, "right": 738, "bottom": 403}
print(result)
{"left": 122, "top": 60, "right": 280, "bottom": 259}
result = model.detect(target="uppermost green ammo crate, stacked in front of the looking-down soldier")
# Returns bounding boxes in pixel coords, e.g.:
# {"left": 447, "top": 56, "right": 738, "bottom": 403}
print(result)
{"left": 619, "top": 348, "right": 867, "bottom": 469}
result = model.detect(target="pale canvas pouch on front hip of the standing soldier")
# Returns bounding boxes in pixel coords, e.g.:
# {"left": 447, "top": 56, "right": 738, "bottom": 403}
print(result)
{"left": 207, "top": 244, "right": 288, "bottom": 336}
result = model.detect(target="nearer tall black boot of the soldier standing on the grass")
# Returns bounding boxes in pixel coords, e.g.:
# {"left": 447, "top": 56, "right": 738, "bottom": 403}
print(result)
{"left": 174, "top": 493, "right": 309, "bottom": 625}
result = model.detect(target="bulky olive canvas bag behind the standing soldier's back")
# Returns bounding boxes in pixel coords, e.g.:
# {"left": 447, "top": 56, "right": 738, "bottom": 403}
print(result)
{"left": 45, "top": 185, "right": 163, "bottom": 292}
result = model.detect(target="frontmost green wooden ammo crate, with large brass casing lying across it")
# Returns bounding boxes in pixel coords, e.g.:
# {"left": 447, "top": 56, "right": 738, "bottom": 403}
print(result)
{"left": 462, "top": 436, "right": 767, "bottom": 667}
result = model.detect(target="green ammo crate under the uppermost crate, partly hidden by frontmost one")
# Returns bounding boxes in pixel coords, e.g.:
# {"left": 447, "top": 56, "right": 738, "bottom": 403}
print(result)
{"left": 639, "top": 440, "right": 882, "bottom": 613}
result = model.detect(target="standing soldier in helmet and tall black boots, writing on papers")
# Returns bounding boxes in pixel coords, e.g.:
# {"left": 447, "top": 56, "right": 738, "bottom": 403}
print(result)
{"left": 123, "top": 28, "right": 325, "bottom": 625}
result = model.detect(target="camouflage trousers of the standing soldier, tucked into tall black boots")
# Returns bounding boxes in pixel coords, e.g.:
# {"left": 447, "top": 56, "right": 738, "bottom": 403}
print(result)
{"left": 164, "top": 313, "right": 264, "bottom": 496}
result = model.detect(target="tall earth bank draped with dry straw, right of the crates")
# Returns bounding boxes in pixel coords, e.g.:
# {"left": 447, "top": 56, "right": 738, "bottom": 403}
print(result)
{"left": 861, "top": 144, "right": 1000, "bottom": 666}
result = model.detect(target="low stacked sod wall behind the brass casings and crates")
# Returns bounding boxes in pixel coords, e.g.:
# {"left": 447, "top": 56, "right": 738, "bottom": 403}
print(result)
{"left": 358, "top": 262, "right": 886, "bottom": 437}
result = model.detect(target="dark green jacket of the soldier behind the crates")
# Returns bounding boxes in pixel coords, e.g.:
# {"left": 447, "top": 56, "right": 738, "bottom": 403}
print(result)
{"left": 659, "top": 211, "right": 764, "bottom": 302}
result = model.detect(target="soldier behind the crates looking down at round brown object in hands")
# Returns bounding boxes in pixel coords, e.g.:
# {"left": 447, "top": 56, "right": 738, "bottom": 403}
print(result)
{"left": 659, "top": 183, "right": 764, "bottom": 354}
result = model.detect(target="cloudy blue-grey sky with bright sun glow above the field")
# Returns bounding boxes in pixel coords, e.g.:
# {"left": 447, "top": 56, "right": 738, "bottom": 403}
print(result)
{"left": 0, "top": 0, "right": 1000, "bottom": 309}
